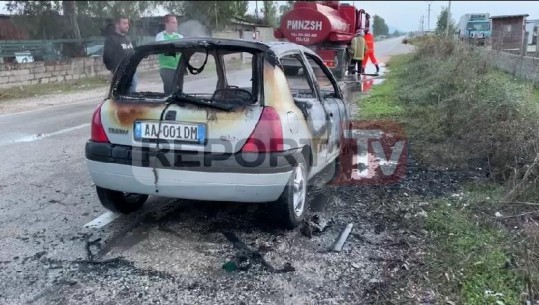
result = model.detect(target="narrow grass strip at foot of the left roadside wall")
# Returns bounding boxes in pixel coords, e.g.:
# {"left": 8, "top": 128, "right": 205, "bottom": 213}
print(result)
{"left": 0, "top": 76, "right": 109, "bottom": 102}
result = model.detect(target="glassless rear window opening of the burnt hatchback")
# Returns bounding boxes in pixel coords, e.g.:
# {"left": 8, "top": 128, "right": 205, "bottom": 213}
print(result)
{"left": 112, "top": 47, "right": 261, "bottom": 106}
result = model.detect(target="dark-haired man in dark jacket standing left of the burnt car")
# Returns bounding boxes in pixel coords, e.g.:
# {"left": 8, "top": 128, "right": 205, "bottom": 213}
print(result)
{"left": 103, "top": 16, "right": 137, "bottom": 93}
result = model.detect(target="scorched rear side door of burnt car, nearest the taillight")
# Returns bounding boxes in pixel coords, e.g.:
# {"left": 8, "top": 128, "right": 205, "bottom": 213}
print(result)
{"left": 280, "top": 50, "right": 330, "bottom": 173}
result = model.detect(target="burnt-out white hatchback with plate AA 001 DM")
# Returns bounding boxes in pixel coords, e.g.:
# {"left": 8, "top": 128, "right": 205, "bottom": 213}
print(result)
{"left": 86, "top": 38, "right": 349, "bottom": 228}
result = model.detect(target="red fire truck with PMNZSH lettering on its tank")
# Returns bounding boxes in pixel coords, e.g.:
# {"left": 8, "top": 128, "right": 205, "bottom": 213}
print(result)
{"left": 274, "top": 1, "right": 370, "bottom": 79}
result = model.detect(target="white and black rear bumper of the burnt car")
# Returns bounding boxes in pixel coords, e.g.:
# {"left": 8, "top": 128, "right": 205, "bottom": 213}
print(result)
{"left": 86, "top": 141, "right": 300, "bottom": 202}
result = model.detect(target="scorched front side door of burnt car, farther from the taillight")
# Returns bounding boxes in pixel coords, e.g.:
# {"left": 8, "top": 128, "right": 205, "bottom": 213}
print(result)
{"left": 304, "top": 53, "right": 348, "bottom": 161}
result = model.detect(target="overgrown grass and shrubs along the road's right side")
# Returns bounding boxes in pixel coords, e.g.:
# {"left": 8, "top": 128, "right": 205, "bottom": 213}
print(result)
{"left": 358, "top": 41, "right": 539, "bottom": 305}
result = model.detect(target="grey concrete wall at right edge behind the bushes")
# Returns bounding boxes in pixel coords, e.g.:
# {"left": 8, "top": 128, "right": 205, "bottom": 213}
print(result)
{"left": 488, "top": 50, "right": 539, "bottom": 86}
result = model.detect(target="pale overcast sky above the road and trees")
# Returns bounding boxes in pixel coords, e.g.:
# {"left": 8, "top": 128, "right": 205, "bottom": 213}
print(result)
{"left": 0, "top": 1, "right": 539, "bottom": 31}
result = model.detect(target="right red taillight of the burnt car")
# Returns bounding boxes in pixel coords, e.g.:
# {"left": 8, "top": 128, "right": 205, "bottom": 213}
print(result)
{"left": 241, "top": 107, "right": 283, "bottom": 153}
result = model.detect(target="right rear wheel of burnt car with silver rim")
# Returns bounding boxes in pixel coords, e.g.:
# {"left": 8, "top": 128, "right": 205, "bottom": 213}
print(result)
{"left": 274, "top": 154, "right": 309, "bottom": 229}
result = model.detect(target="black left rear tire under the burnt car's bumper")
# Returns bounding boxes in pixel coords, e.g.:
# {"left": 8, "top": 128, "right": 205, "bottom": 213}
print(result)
{"left": 96, "top": 186, "right": 149, "bottom": 214}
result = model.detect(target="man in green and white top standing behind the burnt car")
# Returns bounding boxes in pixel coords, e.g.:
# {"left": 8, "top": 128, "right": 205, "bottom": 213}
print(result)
{"left": 155, "top": 14, "right": 183, "bottom": 95}
